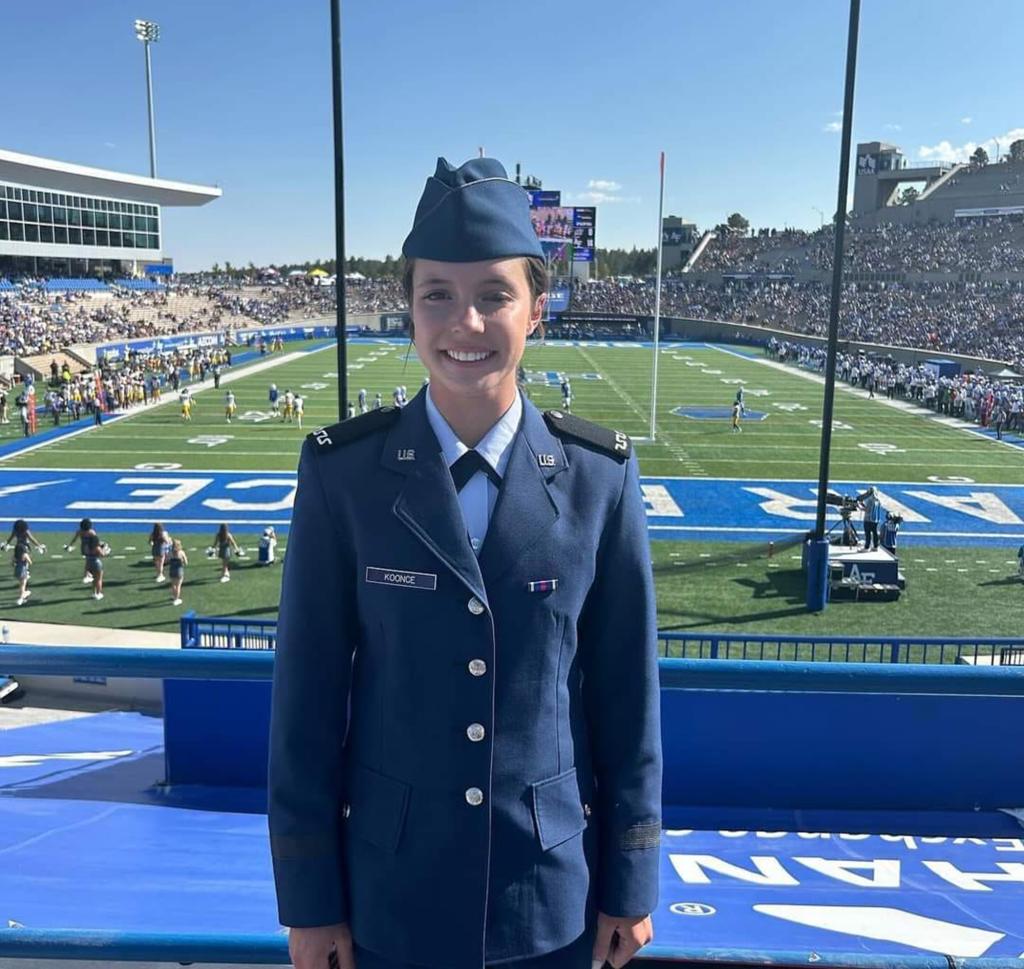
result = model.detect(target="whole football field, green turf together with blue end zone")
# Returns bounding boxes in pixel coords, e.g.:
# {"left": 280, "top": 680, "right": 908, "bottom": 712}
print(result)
{"left": 0, "top": 341, "right": 1024, "bottom": 635}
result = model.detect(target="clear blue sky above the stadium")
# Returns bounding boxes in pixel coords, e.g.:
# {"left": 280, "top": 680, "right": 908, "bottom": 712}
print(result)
{"left": 0, "top": 0, "right": 1024, "bottom": 269}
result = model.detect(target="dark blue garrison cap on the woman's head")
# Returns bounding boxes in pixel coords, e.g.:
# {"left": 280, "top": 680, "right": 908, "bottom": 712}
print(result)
{"left": 401, "top": 158, "right": 544, "bottom": 262}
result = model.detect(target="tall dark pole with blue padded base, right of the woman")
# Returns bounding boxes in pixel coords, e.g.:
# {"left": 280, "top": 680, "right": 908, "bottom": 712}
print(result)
{"left": 807, "top": 0, "right": 860, "bottom": 610}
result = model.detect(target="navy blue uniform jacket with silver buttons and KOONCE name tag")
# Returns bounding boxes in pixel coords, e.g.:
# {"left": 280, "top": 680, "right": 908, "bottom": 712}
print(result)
{"left": 269, "top": 391, "right": 662, "bottom": 969}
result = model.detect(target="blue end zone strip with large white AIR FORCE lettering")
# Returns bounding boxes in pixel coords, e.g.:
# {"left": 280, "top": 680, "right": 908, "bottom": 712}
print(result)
{"left": 0, "top": 468, "right": 1024, "bottom": 540}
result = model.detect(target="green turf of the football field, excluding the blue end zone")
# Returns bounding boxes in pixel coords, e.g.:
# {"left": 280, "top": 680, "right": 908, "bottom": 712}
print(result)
{"left": 0, "top": 335, "right": 1024, "bottom": 636}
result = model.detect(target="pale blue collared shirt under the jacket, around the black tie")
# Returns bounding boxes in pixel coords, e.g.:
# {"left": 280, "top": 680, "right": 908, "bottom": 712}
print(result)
{"left": 427, "top": 387, "right": 522, "bottom": 555}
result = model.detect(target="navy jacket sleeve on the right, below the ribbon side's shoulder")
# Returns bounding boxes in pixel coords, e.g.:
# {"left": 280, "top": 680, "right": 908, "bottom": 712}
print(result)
{"left": 580, "top": 455, "right": 662, "bottom": 918}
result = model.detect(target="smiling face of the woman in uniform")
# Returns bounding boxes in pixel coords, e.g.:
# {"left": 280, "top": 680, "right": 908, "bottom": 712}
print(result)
{"left": 411, "top": 257, "right": 547, "bottom": 397}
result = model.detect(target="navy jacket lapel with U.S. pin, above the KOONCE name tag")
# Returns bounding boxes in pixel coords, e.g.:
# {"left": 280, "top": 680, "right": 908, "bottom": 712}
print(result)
{"left": 381, "top": 390, "right": 489, "bottom": 602}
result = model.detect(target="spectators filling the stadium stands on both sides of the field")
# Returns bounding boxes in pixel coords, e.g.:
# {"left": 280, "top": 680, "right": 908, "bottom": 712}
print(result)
{"left": 0, "top": 216, "right": 1024, "bottom": 367}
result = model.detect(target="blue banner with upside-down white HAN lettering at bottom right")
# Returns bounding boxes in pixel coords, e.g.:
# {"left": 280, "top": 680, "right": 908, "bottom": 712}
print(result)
{"left": 654, "top": 827, "right": 1024, "bottom": 965}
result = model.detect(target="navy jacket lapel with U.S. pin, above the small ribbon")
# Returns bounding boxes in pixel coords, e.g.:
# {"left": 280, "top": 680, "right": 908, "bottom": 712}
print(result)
{"left": 480, "top": 397, "right": 565, "bottom": 582}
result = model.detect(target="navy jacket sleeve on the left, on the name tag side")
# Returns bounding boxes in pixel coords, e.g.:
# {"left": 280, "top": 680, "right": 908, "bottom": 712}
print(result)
{"left": 267, "top": 440, "right": 356, "bottom": 927}
